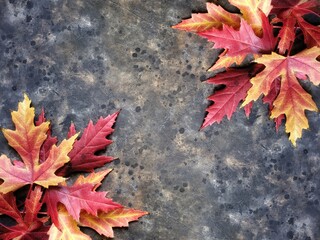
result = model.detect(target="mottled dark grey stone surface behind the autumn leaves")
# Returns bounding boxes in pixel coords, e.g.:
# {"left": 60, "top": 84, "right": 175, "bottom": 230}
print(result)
{"left": 0, "top": 0, "right": 320, "bottom": 240}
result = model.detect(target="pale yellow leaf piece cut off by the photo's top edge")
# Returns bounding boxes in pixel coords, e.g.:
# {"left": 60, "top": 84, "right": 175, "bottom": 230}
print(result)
{"left": 229, "top": 0, "right": 272, "bottom": 37}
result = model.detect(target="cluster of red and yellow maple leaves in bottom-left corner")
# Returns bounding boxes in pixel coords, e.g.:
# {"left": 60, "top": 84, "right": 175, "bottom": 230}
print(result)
{"left": 0, "top": 95, "right": 147, "bottom": 240}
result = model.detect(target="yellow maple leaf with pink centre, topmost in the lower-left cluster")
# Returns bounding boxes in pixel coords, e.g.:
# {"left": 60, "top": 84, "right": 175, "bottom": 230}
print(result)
{"left": 0, "top": 95, "right": 77, "bottom": 193}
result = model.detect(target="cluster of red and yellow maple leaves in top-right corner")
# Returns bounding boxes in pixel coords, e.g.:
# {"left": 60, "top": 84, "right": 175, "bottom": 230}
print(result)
{"left": 173, "top": 0, "right": 320, "bottom": 145}
